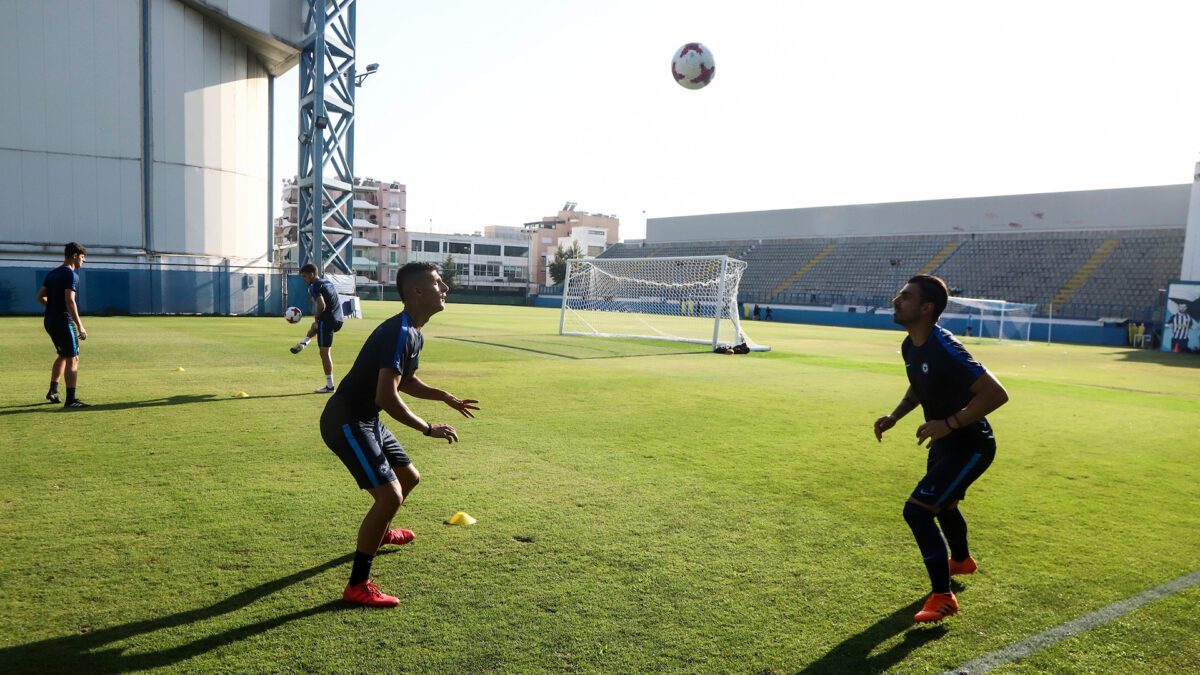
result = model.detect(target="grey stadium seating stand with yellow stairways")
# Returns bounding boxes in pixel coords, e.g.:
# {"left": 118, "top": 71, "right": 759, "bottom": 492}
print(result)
{"left": 601, "top": 227, "right": 1184, "bottom": 321}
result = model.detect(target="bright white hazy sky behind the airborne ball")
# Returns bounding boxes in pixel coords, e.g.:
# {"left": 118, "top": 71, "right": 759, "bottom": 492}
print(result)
{"left": 275, "top": 0, "right": 1200, "bottom": 239}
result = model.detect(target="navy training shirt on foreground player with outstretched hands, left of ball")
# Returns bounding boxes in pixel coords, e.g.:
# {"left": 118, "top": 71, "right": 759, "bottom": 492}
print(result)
{"left": 325, "top": 312, "right": 425, "bottom": 420}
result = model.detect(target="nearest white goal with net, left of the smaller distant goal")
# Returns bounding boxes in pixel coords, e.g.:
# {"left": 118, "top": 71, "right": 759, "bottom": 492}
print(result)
{"left": 558, "top": 256, "right": 770, "bottom": 352}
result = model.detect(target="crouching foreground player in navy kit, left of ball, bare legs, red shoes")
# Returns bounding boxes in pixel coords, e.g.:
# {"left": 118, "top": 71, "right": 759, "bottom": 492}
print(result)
{"left": 320, "top": 258, "right": 479, "bottom": 607}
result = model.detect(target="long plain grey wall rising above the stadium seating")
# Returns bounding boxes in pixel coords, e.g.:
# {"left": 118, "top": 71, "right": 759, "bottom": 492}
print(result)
{"left": 646, "top": 185, "right": 1192, "bottom": 244}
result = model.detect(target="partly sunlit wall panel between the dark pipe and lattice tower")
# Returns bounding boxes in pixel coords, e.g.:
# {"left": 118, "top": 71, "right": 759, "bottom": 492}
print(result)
{"left": 150, "top": 0, "right": 270, "bottom": 259}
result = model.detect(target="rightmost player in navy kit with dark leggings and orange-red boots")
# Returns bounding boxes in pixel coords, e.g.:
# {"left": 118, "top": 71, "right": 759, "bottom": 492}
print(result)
{"left": 875, "top": 274, "right": 1008, "bottom": 623}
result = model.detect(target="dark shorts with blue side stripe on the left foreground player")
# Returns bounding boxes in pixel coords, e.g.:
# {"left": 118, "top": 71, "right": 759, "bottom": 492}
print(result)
{"left": 320, "top": 408, "right": 413, "bottom": 490}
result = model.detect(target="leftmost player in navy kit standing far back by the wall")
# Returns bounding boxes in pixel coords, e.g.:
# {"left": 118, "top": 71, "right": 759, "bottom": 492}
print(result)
{"left": 37, "top": 241, "right": 91, "bottom": 408}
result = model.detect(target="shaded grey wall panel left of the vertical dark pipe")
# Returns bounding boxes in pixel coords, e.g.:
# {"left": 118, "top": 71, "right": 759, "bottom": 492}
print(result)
{"left": 0, "top": 0, "right": 143, "bottom": 249}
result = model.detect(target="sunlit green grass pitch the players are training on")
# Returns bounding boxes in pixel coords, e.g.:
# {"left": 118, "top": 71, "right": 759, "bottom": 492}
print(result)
{"left": 0, "top": 298, "right": 1200, "bottom": 673}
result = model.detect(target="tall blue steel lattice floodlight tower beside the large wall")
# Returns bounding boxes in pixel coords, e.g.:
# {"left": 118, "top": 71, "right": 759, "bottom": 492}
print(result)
{"left": 296, "top": 0, "right": 356, "bottom": 275}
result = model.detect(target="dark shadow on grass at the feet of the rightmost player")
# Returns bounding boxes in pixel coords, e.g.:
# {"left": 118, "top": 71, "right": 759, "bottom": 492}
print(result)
{"left": 797, "top": 583, "right": 961, "bottom": 675}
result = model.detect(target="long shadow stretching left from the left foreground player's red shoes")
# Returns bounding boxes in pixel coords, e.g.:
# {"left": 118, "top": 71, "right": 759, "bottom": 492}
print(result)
{"left": 0, "top": 551, "right": 383, "bottom": 673}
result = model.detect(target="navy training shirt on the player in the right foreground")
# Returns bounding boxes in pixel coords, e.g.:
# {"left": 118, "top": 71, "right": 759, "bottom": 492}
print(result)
{"left": 900, "top": 325, "right": 990, "bottom": 434}
